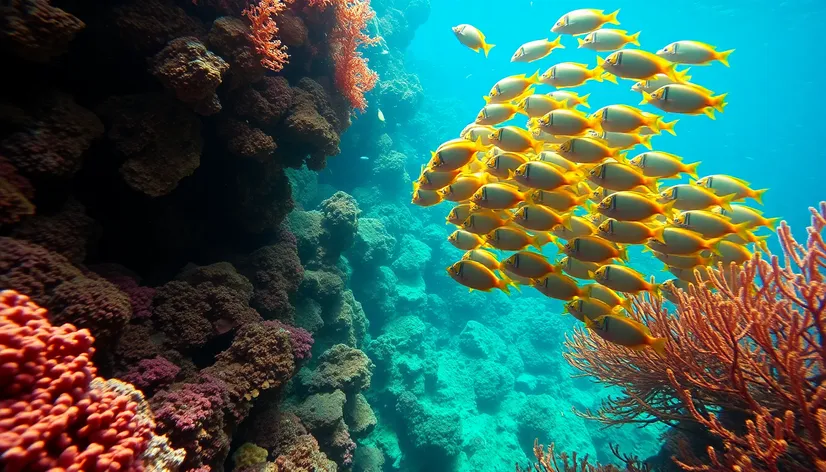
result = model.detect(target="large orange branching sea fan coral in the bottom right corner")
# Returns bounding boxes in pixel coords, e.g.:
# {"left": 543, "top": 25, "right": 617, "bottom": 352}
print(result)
{"left": 565, "top": 203, "right": 826, "bottom": 471}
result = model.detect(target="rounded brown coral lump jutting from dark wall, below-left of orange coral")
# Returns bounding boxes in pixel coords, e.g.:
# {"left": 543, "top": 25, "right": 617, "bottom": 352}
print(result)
{"left": 151, "top": 36, "right": 229, "bottom": 115}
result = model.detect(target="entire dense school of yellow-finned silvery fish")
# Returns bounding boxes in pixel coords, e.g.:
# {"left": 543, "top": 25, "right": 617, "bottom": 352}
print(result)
{"left": 424, "top": 9, "right": 777, "bottom": 354}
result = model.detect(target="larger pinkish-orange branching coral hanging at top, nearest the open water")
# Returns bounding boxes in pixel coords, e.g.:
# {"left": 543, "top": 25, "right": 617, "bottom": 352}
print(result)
{"left": 328, "top": 0, "right": 379, "bottom": 111}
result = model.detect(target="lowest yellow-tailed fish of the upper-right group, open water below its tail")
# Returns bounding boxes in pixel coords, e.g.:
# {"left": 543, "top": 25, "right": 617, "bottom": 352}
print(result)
{"left": 640, "top": 84, "right": 728, "bottom": 120}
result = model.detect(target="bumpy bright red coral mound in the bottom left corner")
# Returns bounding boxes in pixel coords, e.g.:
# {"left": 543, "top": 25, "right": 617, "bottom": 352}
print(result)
{"left": 0, "top": 290, "right": 171, "bottom": 472}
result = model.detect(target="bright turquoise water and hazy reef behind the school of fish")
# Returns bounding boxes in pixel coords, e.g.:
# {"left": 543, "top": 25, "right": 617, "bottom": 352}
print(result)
{"left": 320, "top": 0, "right": 826, "bottom": 471}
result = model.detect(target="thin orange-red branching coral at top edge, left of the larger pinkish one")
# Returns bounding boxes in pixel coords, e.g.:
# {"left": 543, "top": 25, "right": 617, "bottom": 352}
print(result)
{"left": 243, "top": 0, "right": 290, "bottom": 72}
